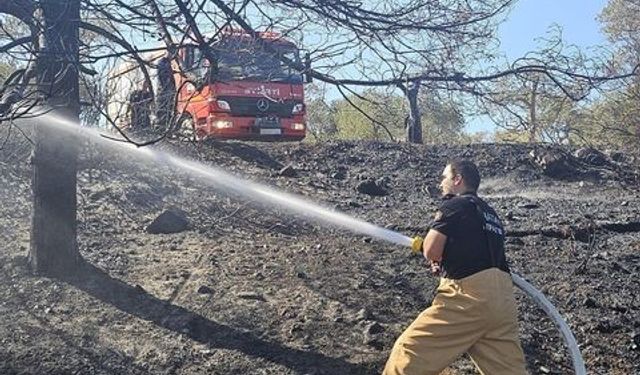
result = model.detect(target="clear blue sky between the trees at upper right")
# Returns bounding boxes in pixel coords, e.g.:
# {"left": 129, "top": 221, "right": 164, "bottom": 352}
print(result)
{"left": 466, "top": 0, "right": 607, "bottom": 132}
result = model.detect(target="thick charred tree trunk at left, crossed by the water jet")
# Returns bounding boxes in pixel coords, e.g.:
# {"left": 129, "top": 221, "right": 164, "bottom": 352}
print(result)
{"left": 29, "top": 0, "right": 80, "bottom": 275}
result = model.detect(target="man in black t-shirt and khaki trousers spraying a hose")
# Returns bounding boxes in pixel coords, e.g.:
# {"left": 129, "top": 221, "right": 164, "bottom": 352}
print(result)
{"left": 383, "top": 159, "right": 527, "bottom": 375}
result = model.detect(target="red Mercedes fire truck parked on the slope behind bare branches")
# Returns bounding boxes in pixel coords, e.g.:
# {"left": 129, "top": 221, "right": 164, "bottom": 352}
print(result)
{"left": 108, "top": 30, "right": 310, "bottom": 141}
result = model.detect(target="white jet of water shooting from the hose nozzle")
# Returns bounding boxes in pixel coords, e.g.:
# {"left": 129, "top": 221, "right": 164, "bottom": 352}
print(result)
{"left": 42, "top": 114, "right": 412, "bottom": 247}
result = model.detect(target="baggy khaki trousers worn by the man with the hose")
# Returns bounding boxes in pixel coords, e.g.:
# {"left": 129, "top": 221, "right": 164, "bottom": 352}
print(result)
{"left": 383, "top": 268, "right": 527, "bottom": 375}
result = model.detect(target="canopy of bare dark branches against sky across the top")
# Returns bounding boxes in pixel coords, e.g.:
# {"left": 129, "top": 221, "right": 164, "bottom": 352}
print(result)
{"left": 0, "top": 0, "right": 635, "bottom": 145}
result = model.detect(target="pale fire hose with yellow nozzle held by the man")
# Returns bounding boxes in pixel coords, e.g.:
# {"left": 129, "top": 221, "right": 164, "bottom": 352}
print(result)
{"left": 410, "top": 236, "right": 587, "bottom": 375}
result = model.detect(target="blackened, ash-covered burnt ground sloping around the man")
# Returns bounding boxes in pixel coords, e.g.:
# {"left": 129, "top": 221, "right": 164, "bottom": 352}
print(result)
{"left": 0, "top": 127, "right": 640, "bottom": 375}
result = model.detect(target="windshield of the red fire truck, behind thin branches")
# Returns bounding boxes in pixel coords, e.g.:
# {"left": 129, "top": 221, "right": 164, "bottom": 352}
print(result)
{"left": 214, "top": 43, "right": 302, "bottom": 83}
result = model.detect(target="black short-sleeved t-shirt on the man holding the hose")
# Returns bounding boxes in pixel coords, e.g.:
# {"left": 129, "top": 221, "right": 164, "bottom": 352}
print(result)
{"left": 431, "top": 194, "right": 509, "bottom": 279}
